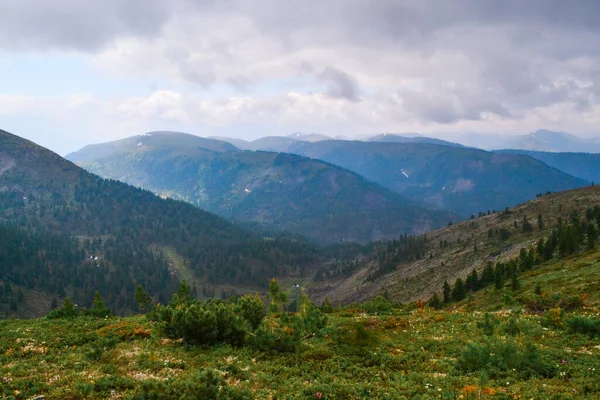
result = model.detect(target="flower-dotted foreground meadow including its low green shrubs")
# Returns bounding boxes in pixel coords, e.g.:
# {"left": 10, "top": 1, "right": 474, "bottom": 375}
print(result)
{"left": 0, "top": 297, "right": 600, "bottom": 400}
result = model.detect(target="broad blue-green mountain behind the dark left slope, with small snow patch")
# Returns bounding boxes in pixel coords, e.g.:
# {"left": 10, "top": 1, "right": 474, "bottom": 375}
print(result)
{"left": 67, "top": 132, "right": 457, "bottom": 242}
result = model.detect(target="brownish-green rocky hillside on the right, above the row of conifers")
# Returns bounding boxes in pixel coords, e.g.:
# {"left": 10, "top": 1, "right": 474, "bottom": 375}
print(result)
{"left": 309, "top": 186, "right": 600, "bottom": 304}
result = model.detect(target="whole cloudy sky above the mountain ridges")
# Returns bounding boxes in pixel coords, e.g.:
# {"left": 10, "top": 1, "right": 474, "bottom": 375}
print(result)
{"left": 0, "top": 0, "right": 600, "bottom": 155}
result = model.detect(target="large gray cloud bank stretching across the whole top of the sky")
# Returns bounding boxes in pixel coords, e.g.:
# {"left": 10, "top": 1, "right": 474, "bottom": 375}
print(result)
{"left": 0, "top": 0, "right": 600, "bottom": 128}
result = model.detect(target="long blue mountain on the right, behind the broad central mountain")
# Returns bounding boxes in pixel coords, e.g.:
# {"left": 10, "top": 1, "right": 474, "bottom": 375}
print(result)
{"left": 246, "top": 140, "right": 588, "bottom": 217}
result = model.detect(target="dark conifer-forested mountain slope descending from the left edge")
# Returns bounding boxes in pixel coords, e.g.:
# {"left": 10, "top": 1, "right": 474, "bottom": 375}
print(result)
{"left": 0, "top": 131, "right": 322, "bottom": 316}
